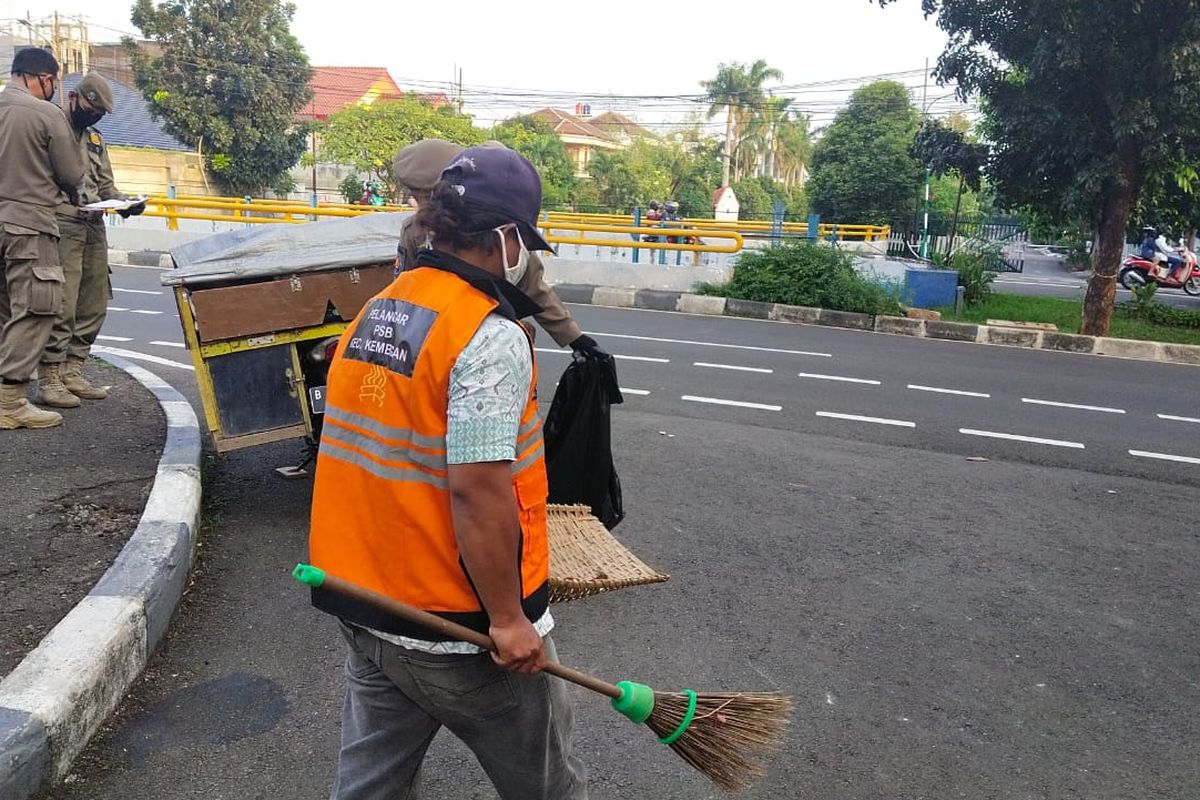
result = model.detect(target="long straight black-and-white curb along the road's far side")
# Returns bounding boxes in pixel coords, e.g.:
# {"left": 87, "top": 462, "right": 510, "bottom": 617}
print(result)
{"left": 554, "top": 284, "right": 1200, "bottom": 366}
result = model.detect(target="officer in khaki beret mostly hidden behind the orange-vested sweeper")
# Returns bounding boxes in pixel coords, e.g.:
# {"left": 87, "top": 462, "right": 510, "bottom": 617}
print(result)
{"left": 391, "top": 139, "right": 604, "bottom": 355}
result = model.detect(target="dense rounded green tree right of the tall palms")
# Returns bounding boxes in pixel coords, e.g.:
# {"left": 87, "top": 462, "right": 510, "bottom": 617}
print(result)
{"left": 806, "top": 80, "right": 925, "bottom": 224}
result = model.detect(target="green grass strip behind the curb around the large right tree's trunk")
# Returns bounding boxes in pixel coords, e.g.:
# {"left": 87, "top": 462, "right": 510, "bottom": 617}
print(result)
{"left": 938, "top": 294, "right": 1200, "bottom": 344}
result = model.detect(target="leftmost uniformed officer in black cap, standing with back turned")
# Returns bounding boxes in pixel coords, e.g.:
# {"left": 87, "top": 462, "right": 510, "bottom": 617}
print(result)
{"left": 0, "top": 48, "right": 84, "bottom": 431}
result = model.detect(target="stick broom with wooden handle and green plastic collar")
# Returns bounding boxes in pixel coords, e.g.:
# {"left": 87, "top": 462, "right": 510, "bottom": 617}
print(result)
{"left": 292, "top": 564, "right": 792, "bottom": 792}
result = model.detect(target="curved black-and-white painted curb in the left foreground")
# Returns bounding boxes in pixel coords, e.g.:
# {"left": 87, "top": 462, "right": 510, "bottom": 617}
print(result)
{"left": 0, "top": 355, "right": 200, "bottom": 800}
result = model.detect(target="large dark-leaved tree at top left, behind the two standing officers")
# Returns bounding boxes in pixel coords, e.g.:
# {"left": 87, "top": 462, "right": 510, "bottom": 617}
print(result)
{"left": 125, "top": 0, "right": 312, "bottom": 194}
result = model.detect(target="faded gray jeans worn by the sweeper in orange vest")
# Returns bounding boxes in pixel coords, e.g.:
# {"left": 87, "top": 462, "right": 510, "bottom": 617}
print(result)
{"left": 330, "top": 625, "right": 588, "bottom": 800}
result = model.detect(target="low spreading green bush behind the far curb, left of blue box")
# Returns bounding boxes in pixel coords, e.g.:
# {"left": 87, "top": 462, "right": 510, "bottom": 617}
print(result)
{"left": 701, "top": 240, "right": 900, "bottom": 314}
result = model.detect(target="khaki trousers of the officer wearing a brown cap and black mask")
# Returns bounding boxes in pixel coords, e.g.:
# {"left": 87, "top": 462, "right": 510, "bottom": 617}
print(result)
{"left": 42, "top": 217, "right": 113, "bottom": 363}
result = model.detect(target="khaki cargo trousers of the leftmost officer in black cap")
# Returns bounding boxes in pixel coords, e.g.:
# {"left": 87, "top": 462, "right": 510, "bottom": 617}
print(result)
{"left": 0, "top": 223, "right": 65, "bottom": 384}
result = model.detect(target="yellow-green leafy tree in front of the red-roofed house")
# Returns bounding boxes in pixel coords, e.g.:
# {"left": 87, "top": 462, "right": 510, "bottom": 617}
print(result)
{"left": 320, "top": 95, "right": 484, "bottom": 199}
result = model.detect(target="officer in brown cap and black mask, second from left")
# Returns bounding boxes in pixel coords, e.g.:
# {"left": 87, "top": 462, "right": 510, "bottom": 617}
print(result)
{"left": 37, "top": 72, "right": 145, "bottom": 408}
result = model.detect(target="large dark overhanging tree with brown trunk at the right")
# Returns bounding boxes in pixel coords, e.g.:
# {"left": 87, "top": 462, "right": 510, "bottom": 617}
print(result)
{"left": 878, "top": 0, "right": 1200, "bottom": 336}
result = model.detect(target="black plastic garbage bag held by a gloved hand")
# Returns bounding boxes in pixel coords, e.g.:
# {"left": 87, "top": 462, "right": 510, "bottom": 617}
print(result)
{"left": 542, "top": 354, "right": 625, "bottom": 530}
